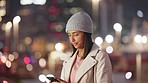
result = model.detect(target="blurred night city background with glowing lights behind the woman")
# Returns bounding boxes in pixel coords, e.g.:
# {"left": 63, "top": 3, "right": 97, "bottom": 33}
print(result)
{"left": 0, "top": 0, "right": 148, "bottom": 83}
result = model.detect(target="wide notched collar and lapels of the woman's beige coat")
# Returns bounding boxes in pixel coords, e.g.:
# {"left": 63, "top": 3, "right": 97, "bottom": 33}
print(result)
{"left": 66, "top": 44, "right": 99, "bottom": 83}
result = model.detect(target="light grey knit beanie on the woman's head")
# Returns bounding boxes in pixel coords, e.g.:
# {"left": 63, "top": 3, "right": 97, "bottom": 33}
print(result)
{"left": 66, "top": 12, "right": 93, "bottom": 34}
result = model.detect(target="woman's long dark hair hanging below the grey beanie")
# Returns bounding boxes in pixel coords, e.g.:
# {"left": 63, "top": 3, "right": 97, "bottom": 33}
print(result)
{"left": 71, "top": 32, "right": 93, "bottom": 58}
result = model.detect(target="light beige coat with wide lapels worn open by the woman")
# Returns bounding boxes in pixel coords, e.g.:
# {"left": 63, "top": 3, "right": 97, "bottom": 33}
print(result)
{"left": 61, "top": 44, "right": 112, "bottom": 83}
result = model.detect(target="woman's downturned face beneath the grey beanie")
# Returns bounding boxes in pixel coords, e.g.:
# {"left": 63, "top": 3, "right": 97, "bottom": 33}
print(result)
{"left": 67, "top": 30, "right": 84, "bottom": 49}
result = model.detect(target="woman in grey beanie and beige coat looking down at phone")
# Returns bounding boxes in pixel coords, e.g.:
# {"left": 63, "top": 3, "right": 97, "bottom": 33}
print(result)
{"left": 52, "top": 12, "right": 112, "bottom": 83}
